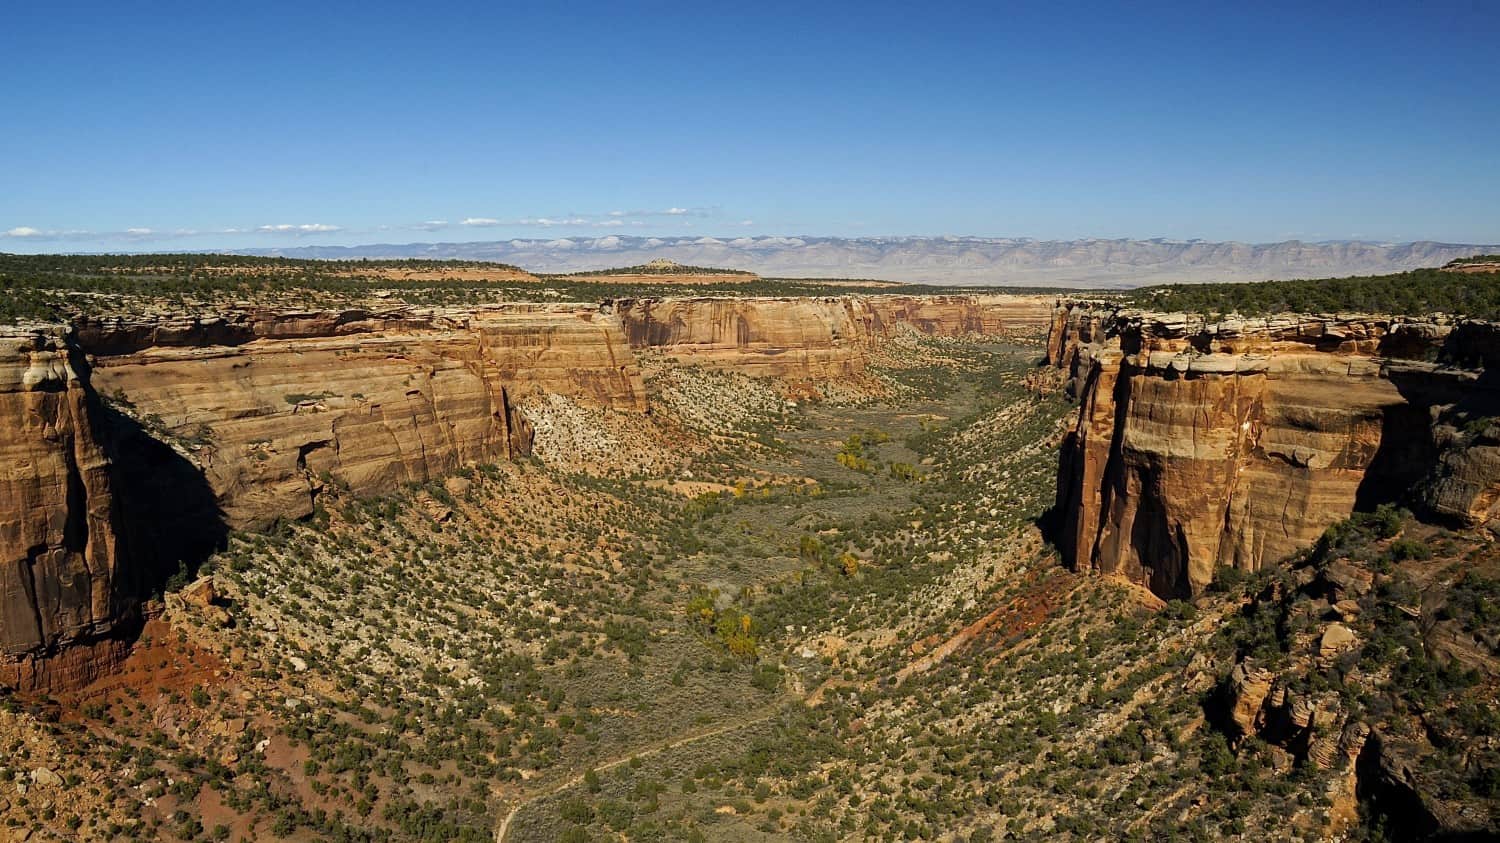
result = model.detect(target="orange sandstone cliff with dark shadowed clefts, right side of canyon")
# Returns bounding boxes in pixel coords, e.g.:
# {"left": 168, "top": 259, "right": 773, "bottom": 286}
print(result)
{"left": 1049, "top": 303, "right": 1500, "bottom": 597}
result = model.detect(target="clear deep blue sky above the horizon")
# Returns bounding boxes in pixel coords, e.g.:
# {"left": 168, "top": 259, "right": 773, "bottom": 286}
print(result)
{"left": 0, "top": 0, "right": 1500, "bottom": 251}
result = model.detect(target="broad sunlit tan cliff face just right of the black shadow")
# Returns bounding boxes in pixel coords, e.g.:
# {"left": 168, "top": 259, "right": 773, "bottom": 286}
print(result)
{"left": 80, "top": 306, "right": 645, "bottom": 528}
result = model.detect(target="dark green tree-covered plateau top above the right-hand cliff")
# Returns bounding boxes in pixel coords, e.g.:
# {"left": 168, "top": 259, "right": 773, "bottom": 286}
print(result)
{"left": 1125, "top": 264, "right": 1500, "bottom": 320}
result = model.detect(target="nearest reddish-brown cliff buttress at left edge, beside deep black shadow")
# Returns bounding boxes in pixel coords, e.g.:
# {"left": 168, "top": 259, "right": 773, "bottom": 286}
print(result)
{"left": 0, "top": 329, "right": 131, "bottom": 686}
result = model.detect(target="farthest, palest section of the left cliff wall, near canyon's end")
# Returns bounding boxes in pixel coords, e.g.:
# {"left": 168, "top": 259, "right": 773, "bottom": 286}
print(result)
{"left": 606, "top": 294, "right": 1052, "bottom": 381}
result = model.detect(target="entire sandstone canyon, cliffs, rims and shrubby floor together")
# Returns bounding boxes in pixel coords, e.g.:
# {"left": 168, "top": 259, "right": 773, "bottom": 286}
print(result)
{"left": 0, "top": 250, "right": 1500, "bottom": 843}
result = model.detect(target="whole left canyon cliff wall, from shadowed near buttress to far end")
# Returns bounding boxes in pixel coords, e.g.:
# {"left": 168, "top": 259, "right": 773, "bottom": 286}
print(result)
{"left": 0, "top": 294, "right": 1052, "bottom": 690}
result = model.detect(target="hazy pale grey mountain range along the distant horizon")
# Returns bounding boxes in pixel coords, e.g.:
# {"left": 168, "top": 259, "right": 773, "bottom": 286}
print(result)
{"left": 234, "top": 237, "right": 1500, "bottom": 287}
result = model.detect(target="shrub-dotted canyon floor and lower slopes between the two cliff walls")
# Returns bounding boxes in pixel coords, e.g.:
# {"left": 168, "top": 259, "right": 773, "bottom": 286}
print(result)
{"left": 0, "top": 328, "right": 1410, "bottom": 842}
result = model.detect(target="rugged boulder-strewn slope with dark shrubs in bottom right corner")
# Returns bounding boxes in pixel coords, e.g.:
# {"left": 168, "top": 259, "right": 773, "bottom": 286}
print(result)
{"left": 1209, "top": 507, "right": 1500, "bottom": 840}
